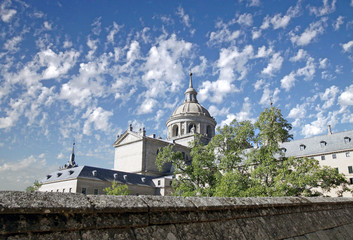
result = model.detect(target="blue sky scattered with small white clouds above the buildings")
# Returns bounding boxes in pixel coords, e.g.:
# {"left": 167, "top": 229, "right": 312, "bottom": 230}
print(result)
{"left": 0, "top": 0, "right": 353, "bottom": 190}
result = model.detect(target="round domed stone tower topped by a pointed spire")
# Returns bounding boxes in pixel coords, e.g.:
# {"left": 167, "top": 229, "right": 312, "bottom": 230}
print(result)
{"left": 166, "top": 73, "right": 217, "bottom": 146}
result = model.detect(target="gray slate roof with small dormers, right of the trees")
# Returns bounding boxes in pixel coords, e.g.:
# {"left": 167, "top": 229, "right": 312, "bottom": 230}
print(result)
{"left": 280, "top": 130, "right": 353, "bottom": 157}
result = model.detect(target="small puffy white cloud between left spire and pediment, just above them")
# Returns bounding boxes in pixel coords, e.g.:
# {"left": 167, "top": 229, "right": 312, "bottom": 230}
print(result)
{"left": 82, "top": 107, "right": 113, "bottom": 135}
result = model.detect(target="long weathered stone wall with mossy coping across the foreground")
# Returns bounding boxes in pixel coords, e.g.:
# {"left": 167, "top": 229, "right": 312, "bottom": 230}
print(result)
{"left": 0, "top": 192, "right": 353, "bottom": 240}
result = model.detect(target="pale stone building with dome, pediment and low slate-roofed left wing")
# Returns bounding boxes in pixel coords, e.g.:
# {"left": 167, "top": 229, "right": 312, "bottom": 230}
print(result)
{"left": 39, "top": 73, "right": 217, "bottom": 195}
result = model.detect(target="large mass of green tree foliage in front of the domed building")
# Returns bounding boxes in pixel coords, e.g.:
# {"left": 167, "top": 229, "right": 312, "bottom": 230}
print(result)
{"left": 156, "top": 106, "right": 348, "bottom": 197}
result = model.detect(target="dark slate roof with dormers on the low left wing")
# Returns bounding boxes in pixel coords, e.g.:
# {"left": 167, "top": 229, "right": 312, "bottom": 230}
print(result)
{"left": 41, "top": 166, "right": 160, "bottom": 187}
